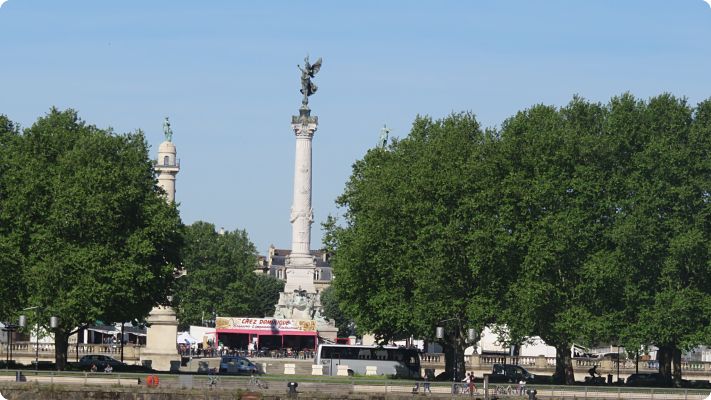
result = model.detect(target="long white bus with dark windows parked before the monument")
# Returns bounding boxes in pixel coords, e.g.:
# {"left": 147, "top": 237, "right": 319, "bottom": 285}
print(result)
{"left": 314, "top": 344, "right": 420, "bottom": 379}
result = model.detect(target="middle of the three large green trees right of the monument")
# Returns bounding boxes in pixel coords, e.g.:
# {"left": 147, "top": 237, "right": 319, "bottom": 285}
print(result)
{"left": 497, "top": 98, "right": 623, "bottom": 383}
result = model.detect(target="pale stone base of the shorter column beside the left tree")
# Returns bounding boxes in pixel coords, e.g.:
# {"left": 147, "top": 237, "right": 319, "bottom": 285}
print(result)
{"left": 141, "top": 307, "right": 180, "bottom": 371}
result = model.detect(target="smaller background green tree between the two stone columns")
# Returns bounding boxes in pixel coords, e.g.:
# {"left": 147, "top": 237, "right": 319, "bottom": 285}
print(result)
{"left": 175, "top": 221, "right": 284, "bottom": 328}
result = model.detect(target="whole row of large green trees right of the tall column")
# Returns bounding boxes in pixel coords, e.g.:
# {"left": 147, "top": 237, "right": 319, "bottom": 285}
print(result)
{"left": 325, "top": 94, "right": 711, "bottom": 382}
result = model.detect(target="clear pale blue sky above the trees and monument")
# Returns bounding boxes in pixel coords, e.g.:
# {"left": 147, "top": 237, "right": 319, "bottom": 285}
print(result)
{"left": 0, "top": 0, "right": 711, "bottom": 253}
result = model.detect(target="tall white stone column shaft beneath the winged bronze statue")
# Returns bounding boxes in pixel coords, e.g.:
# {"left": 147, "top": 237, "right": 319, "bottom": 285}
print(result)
{"left": 284, "top": 108, "right": 318, "bottom": 293}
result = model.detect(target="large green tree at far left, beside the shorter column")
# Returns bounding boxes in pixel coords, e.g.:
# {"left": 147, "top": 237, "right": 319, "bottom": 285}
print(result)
{"left": 0, "top": 109, "right": 182, "bottom": 369}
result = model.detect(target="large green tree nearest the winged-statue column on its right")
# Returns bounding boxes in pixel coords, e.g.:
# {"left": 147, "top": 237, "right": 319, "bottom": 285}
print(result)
{"left": 326, "top": 114, "right": 501, "bottom": 377}
